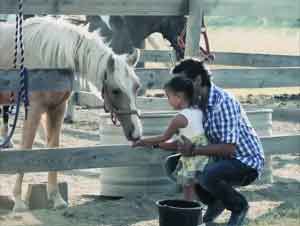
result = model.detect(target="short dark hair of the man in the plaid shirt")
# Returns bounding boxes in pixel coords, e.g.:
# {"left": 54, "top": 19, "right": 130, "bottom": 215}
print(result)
{"left": 172, "top": 58, "right": 211, "bottom": 87}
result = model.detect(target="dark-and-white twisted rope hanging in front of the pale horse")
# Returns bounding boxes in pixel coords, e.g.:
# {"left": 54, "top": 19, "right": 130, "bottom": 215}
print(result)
{"left": 0, "top": 0, "right": 29, "bottom": 148}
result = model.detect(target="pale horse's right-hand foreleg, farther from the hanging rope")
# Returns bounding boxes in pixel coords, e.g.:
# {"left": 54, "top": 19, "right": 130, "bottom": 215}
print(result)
{"left": 45, "top": 103, "right": 68, "bottom": 209}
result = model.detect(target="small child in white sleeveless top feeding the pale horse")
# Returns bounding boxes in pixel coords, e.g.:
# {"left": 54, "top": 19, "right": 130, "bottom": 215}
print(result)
{"left": 133, "top": 76, "right": 207, "bottom": 200}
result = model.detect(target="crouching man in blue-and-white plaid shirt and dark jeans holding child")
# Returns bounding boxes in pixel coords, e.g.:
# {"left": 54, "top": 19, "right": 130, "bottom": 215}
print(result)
{"left": 172, "top": 59, "right": 264, "bottom": 226}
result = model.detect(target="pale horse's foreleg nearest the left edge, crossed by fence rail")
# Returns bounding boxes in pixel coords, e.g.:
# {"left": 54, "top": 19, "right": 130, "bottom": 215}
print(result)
{"left": 13, "top": 106, "right": 41, "bottom": 212}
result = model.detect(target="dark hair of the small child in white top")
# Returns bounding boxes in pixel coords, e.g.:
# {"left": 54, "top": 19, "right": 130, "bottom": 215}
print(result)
{"left": 164, "top": 76, "right": 194, "bottom": 105}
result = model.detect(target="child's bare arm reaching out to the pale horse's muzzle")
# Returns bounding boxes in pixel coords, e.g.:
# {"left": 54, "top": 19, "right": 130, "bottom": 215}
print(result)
{"left": 133, "top": 114, "right": 188, "bottom": 146}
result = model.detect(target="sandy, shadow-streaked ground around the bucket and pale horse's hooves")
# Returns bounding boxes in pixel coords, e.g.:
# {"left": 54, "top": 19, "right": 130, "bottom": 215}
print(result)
{"left": 0, "top": 100, "right": 300, "bottom": 226}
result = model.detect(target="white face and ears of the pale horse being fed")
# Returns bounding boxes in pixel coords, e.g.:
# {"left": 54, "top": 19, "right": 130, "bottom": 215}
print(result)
{"left": 102, "top": 50, "right": 142, "bottom": 140}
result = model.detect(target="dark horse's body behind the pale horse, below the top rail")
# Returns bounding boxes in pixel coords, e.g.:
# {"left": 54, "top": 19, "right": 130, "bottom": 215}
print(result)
{"left": 109, "top": 16, "right": 187, "bottom": 60}
